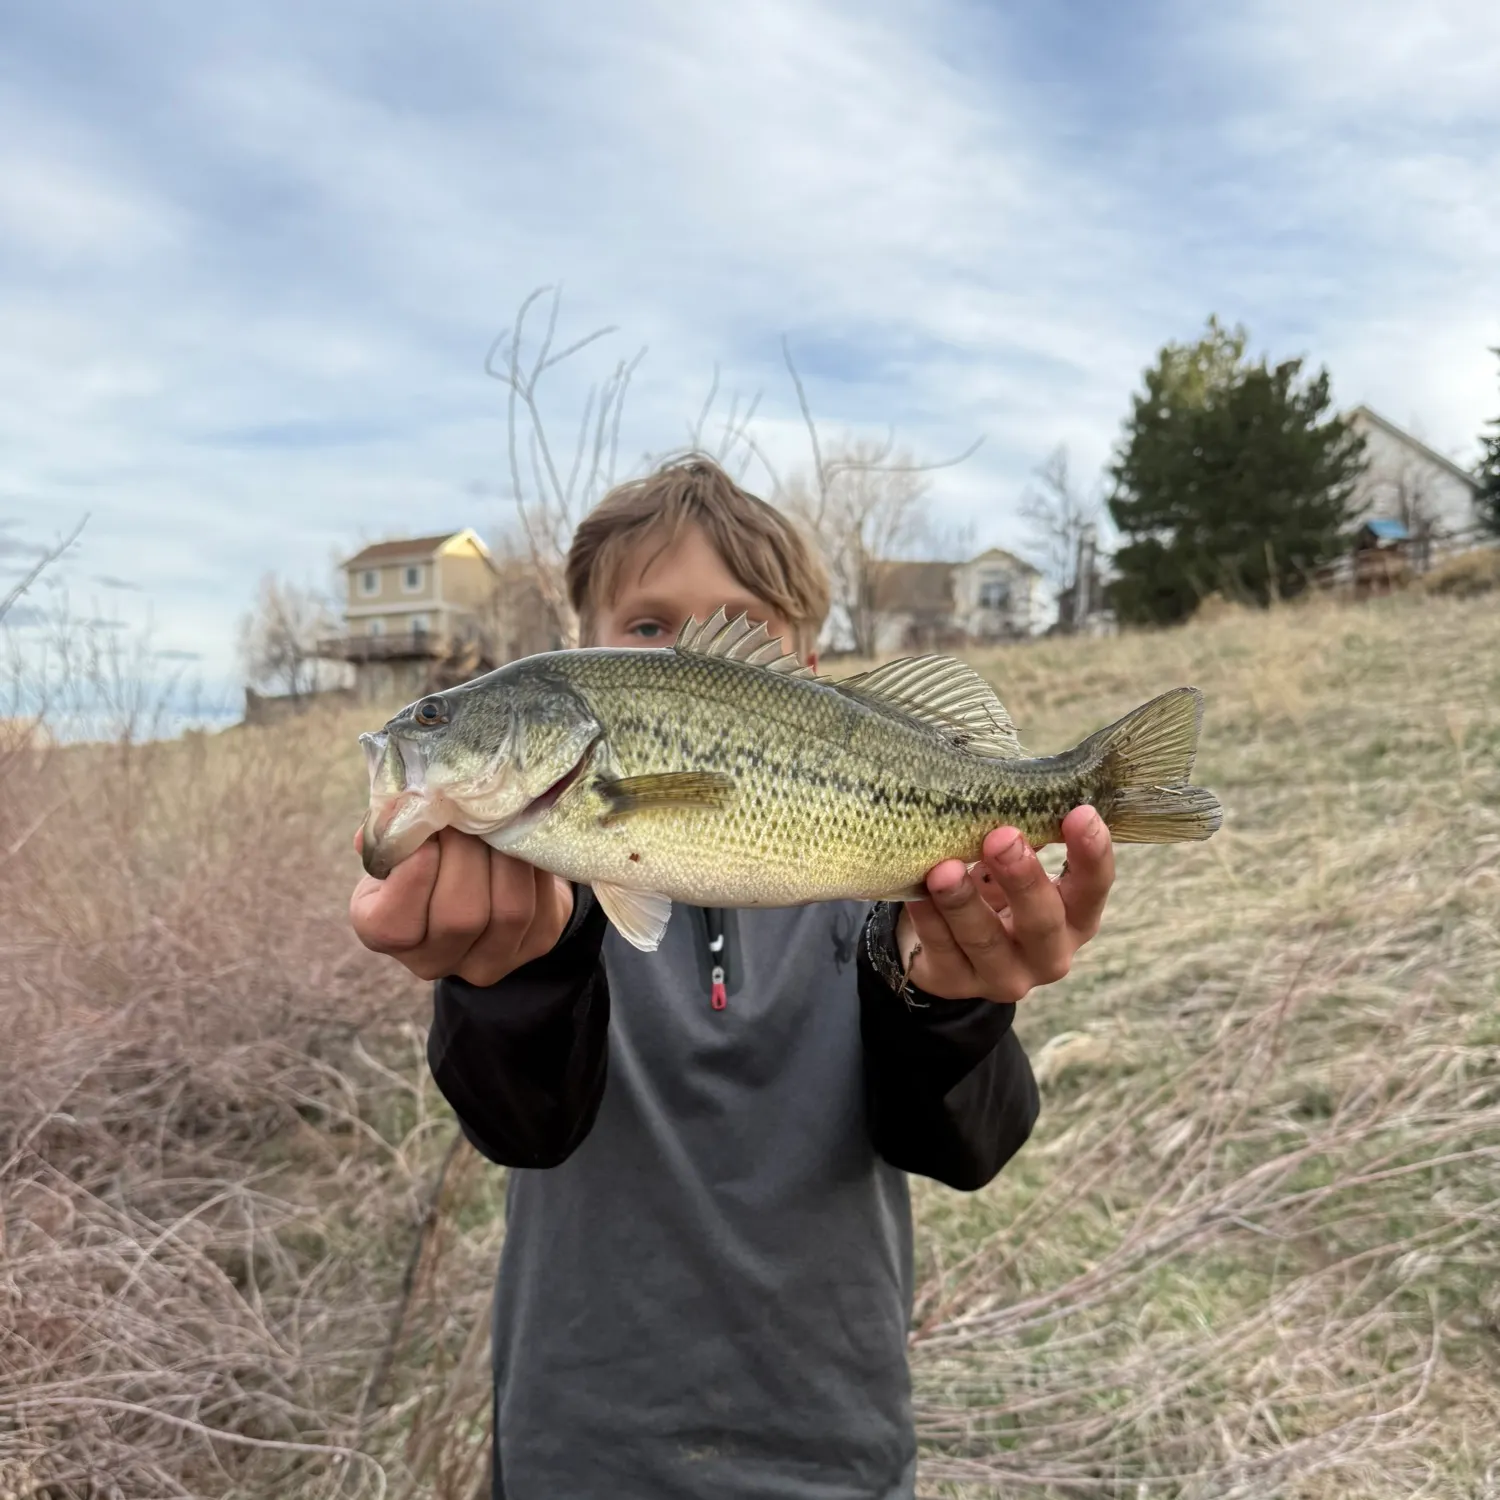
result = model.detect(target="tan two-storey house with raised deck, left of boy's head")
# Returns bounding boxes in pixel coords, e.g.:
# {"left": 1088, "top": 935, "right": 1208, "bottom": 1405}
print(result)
{"left": 318, "top": 528, "right": 560, "bottom": 702}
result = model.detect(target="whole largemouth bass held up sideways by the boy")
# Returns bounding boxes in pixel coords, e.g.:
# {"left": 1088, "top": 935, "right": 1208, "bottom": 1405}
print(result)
{"left": 360, "top": 609, "right": 1223, "bottom": 951}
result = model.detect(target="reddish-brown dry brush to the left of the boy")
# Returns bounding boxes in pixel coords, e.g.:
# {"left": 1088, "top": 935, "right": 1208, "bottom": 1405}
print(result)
{"left": 0, "top": 693, "right": 504, "bottom": 1500}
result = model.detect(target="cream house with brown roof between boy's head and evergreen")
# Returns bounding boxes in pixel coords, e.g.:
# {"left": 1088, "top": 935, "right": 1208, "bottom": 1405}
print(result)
{"left": 821, "top": 548, "right": 1046, "bottom": 656}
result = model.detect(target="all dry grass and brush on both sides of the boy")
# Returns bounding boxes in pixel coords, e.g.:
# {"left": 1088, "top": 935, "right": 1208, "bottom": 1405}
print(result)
{"left": 0, "top": 597, "right": 1500, "bottom": 1500}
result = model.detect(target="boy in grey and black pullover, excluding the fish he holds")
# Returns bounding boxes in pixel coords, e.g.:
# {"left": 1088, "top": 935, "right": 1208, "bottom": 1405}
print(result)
{"left": 351, "top": 458, "right": 1113, "bottom": 1500}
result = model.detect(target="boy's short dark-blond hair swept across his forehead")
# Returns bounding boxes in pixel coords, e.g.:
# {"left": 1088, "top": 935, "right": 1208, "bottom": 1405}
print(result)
{"left": 567, "top": 453, "right": 828, "bottom": 653}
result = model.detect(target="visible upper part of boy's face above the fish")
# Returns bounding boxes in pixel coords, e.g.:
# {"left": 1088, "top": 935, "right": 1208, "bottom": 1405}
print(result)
{"left": 590, "top": 527, "right": 815, "bottom": 662}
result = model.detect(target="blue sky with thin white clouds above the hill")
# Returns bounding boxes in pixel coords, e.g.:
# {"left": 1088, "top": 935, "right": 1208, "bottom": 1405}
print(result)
{"left": 0, "top": 0, "right": 1500, "bottom": 702}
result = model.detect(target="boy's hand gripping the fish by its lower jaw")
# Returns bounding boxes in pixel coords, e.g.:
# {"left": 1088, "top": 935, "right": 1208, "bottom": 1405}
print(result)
{"left": 350, "top": 828, "right": 573, "bottom": 984}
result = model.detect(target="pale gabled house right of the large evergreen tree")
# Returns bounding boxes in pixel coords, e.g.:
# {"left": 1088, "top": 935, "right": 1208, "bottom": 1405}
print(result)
{"left": 1349, "top": 407, "right": 1479, "bottom": 555}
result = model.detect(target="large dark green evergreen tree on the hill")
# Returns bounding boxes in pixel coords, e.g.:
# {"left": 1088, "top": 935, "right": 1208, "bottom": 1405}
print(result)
{"left": 1109, "top": 318, "right": 1364, "bottom": 624}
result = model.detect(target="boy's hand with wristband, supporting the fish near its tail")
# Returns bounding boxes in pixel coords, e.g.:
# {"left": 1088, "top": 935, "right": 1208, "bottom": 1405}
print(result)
{"left": 896, "top": 807, "right": 1115, "bottom": 1004}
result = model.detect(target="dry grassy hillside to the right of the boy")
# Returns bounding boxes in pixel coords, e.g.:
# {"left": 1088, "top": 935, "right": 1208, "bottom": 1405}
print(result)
{"left": 914, "top": 600, "right": 1500, "bottom": 1497}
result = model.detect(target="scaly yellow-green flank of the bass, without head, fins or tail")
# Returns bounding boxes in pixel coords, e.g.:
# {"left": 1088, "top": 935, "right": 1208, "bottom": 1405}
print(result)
{"left": 510, "top": 651, "right": 1089, "bottom": 906}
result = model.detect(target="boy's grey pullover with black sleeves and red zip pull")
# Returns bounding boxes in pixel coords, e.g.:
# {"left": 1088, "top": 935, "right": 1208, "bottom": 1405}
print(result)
{"left": 429, "top": 890, "right": 1038, "bottom": 1500}
